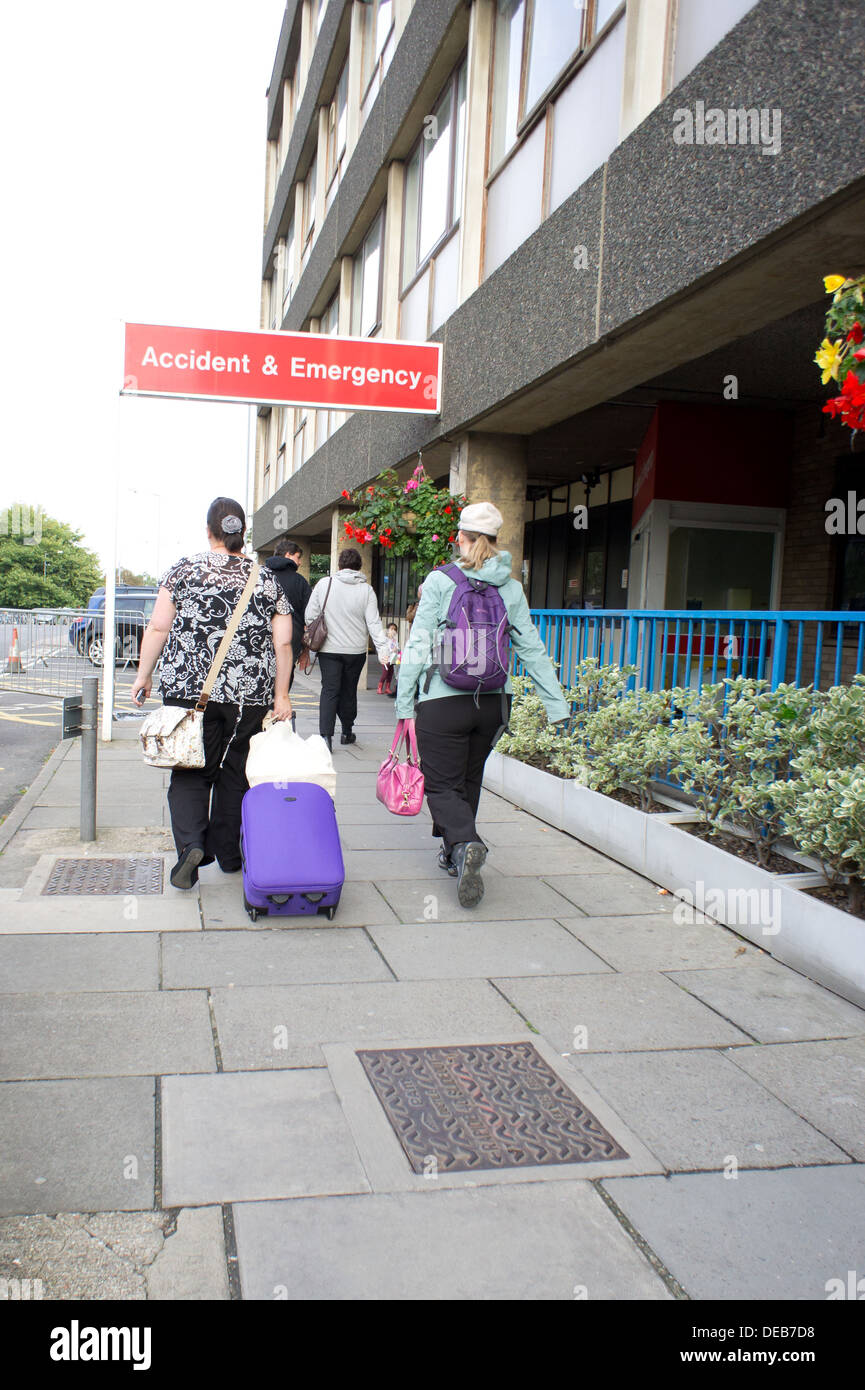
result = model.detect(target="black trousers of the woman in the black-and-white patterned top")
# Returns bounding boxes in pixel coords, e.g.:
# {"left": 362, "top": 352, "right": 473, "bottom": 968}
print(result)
{"left": 164, "top": 698, "right": 267, "bottom": 869}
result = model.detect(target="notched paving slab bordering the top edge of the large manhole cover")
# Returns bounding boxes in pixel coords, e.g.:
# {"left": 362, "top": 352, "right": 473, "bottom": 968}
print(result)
{"left": 213, "top": 980, "right": 524, "bottom": 1072}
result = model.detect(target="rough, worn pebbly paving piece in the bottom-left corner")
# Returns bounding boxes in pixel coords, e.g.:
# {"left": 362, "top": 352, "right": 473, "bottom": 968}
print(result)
{"left": 0, "top": 1211, "right": 170, "bottom": 1302}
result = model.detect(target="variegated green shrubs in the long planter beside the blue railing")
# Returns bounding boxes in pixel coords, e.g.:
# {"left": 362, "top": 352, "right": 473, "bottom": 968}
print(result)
{"left": 498, "top": 659, "right": 865, "bottom": 906}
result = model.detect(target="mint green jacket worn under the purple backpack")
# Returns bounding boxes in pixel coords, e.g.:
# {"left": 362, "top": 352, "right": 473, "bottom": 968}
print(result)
{"left": 396, "top": 550, "right": 570, "bottom": 723}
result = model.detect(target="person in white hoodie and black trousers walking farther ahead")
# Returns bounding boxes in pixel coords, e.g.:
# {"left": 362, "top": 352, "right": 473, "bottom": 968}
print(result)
{"left": 306, "top": 549, "right": 388, "bottom": 751}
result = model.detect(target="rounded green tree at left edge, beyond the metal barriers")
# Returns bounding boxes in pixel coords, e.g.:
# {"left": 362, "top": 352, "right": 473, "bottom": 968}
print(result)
{"left": 0, "top": 503, "right": 103, "bottom": 607}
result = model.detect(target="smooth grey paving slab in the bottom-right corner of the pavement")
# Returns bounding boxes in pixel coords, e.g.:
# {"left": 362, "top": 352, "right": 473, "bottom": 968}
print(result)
{"left": 604, "top": 1165, "right": 865, "bottom": 1306}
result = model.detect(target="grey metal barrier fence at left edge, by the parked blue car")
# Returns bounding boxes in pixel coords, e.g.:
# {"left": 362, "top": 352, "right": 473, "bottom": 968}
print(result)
{"left": 0, "top": 603, "right": 147, "bottom": 696}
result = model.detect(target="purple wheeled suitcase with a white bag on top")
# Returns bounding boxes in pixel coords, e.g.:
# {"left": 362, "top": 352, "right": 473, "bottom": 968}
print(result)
{"left": 241, "top": 783, "right": 345, "bottom": 922}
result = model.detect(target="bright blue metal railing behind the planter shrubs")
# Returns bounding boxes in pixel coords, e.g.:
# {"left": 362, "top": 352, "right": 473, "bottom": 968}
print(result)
{"left": 525, "top": 609, "right": 865, "bottom": 691}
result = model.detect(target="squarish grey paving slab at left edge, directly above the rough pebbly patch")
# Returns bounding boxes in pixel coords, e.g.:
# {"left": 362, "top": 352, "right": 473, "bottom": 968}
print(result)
{"left": 0, "top": 1076, "right": 154, "bottom": 1215}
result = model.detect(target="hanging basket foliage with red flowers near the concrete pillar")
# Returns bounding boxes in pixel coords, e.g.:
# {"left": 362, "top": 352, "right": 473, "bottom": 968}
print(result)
{"left": 342, "top": 464, "right": 466, "bottom": 571}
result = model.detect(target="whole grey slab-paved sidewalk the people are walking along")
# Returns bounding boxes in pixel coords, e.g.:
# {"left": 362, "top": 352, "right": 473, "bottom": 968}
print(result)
{"left": 0, "top": 677, "right": 865, "bottom": 1300}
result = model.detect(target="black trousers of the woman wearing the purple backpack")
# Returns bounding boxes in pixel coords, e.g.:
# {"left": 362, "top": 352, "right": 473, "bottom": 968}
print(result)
{"left": 414, "top": 692, "right": 510, "bottom": 853}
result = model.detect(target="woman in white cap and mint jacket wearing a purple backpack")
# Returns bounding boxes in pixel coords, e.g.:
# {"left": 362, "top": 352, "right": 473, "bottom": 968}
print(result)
{"left": 396, "top": 502, "right": 570, "bottom": 908}
